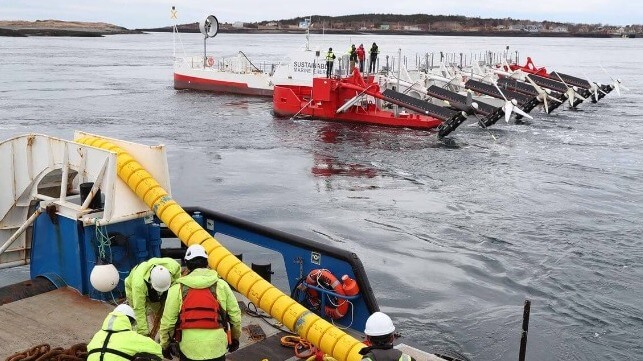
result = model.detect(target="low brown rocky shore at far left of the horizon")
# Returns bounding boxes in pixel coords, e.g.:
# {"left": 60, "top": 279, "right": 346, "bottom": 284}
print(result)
{"left": 0, "top": 20, "right": 143, "bottom": 37}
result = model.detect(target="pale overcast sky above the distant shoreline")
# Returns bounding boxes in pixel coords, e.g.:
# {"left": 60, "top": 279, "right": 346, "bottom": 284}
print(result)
{"left": 0, "top": 0, "right": 643, "bottom": 29}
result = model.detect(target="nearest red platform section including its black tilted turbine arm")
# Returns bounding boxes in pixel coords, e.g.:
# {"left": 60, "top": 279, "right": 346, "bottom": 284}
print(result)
{"left": 273, "top": 69, "right": 466, "bottom": 136}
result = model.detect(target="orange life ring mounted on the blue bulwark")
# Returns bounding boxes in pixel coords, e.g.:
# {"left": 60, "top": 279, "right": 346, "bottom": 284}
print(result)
{"left": 303, "top": 268, "right": 359, "bottom": 320}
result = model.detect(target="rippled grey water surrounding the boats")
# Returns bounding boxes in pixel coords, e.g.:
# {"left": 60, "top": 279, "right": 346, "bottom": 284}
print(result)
{"left": 0, "top": 34, "right": 643, "bottom": 360}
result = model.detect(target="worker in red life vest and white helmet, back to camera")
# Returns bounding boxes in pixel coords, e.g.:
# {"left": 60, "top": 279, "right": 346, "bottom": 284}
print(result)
{"left": 160, "top": 245, "right": 241, "bottom": 361}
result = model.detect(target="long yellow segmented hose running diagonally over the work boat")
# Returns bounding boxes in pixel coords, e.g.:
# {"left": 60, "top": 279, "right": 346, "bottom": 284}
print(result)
{"left": 76, "top": 136, "right": 364, "bottom": 361}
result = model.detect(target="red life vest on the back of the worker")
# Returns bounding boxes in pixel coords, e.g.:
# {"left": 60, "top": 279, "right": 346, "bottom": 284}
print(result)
{"left": 174, "top": 283, "right": 226, "bottom": 341}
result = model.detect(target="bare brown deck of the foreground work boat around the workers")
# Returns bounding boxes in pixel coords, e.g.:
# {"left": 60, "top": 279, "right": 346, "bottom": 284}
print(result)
{"left": 0, "top": 287, "right": 442, "bottom": 361}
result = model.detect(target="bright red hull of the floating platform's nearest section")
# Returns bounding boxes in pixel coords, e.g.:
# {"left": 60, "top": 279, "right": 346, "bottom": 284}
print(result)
{"left": 272, "top": 78, "right": 442, "bottom": 129}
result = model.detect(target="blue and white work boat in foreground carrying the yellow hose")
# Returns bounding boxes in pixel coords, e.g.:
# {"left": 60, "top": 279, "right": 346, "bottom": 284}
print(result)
{"left": 0, "top": 132, "right": 456, "bottom": 361}
